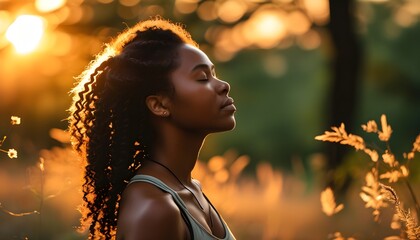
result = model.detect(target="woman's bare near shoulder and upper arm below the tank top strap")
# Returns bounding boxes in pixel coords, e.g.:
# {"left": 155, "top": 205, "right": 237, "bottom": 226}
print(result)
{"left": 117, "top": 183, "right": 187, "bottom": 240}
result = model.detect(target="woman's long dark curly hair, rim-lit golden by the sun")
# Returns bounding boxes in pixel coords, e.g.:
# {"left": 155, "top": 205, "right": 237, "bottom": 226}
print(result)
{"left": 69, "top": 17, "right": 198, "bottom": 239}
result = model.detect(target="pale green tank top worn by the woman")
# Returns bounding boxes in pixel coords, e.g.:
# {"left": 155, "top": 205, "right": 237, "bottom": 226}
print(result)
{"left": 129, "top": 175, "right": 235, "bottom": 240}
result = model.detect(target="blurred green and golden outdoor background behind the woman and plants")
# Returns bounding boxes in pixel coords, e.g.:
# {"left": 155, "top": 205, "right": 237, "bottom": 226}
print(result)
{"left": 0, "top": 0, "right": 420, "bottom": 239}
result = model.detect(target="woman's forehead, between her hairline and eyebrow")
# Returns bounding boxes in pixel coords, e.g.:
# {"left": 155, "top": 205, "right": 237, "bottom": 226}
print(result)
{"left": 177, "top": 44, "right": 213, "bottom": 72}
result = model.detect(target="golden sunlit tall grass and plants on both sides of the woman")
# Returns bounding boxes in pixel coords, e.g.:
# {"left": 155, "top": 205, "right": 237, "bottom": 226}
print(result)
{"left": 0, "top": 114, "right": 420, "bottom": 240}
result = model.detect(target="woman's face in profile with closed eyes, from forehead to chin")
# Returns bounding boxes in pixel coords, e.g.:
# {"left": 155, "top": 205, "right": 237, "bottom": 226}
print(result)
{"left": 169, "top": 44, "right": 236, "bottom": 134}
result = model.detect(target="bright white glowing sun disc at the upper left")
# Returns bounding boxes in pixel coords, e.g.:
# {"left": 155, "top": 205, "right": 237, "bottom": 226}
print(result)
{"left": 6, "top": 15, "right": 45, "bottom": 54}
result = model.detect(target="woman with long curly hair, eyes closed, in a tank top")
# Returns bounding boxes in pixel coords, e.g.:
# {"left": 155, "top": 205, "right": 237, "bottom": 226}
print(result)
{"left": 70, "top": 18, "right": 236, "bottom": 240}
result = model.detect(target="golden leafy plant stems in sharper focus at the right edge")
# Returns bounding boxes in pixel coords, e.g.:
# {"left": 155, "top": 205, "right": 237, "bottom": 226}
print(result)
{"left": 315, "top": 115, "right": 420, "bottom": 240}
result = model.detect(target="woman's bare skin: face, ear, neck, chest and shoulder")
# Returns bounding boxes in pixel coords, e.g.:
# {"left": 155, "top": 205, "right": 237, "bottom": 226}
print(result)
{"left": 117, "top": 44, "right": 236, "bottom": 240}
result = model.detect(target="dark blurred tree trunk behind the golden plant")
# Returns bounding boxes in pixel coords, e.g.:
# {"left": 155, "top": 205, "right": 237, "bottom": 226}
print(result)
{"left": 327, "top": 0, "right": 362, "bottom": 190}
